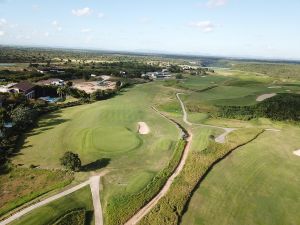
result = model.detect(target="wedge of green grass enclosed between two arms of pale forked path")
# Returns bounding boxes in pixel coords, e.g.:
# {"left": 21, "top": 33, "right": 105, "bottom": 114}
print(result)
{"left": 12, "top": 186, "right": 94, "bottom": 225}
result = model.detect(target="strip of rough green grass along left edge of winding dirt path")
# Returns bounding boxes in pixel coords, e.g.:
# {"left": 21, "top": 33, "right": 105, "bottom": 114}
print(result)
{"left": 105, "top": 140, "right": 186, "bottom": 225}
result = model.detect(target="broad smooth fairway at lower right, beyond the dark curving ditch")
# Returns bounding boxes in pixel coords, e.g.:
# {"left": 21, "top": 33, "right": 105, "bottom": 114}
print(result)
{"left": 182, "top": 126, "right": 300, "bottom": 225}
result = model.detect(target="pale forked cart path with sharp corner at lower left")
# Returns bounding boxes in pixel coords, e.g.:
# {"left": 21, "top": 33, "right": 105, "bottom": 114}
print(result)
{"left": 0, "top": 176, "right": 103, "bottom": 225}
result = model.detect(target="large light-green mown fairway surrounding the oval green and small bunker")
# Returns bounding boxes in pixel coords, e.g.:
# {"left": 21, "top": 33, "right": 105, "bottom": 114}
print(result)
{"left": 13, "top": 82, "right": 179, "bottom": 225}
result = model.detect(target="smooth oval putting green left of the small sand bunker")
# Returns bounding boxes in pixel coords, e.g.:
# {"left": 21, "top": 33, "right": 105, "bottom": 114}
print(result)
{"left": 75, "top": 126, "right": 142, "bottom": 153}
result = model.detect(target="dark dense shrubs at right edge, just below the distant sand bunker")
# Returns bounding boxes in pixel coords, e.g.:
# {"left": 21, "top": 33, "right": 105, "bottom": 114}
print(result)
{"left": 219, "top": 94, "right": 300, "bottom": 121}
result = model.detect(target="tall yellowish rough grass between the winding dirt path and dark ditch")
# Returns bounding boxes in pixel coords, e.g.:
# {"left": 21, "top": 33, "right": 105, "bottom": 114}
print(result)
{"left": 139, "top": 128, "right": 263, "bottom": 225}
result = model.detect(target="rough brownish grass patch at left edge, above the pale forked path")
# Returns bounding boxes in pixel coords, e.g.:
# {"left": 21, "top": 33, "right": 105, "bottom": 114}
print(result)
{"left": 0, "top": 167, "right": 73, "bottom": 216}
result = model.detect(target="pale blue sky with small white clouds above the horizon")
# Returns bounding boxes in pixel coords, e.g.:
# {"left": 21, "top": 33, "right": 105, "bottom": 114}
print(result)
{"left": 0, "top": 0, "right": 300, "bottom": 59}
